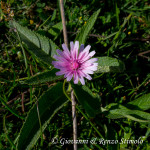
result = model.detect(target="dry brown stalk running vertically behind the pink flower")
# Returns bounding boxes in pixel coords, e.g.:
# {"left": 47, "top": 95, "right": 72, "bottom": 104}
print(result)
{"left": 60, "top": 0, "right": 77, "bottom": 150}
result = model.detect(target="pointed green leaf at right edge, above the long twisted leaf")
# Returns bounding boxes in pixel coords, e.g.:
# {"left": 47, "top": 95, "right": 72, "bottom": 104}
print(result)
{"left": 126, "top": 93, "right": 150, "bottom": 110}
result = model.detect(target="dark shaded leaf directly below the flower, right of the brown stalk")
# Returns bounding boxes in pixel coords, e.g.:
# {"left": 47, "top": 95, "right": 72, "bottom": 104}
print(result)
{"left": 72, "top": 84, "right": 100, "bottom": 117}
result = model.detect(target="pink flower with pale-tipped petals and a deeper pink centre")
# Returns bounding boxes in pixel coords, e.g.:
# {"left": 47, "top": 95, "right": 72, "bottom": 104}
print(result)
{"left": 52, "top": 41, "right": 98, "bottom": 85}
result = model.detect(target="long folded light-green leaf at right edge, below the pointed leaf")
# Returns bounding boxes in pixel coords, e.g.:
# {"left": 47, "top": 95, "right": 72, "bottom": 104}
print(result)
{"left": 107, "top": 103, "right": 150, "bottom": 122}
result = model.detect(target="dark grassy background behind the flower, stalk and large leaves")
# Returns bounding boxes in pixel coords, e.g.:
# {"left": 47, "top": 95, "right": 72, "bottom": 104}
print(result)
{"left": 0, "top": 0, "right": 150, "bottom": 150}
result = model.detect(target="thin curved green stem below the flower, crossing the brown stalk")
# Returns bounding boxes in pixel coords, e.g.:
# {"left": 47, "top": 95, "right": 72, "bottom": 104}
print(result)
{"left": 63, "top": 80, "right": 104, "bottom": 138}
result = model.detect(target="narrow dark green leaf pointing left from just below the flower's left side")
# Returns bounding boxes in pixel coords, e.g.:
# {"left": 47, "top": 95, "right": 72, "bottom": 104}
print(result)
{"left": 24, "top": 68, "right": 64, "bottom": 85}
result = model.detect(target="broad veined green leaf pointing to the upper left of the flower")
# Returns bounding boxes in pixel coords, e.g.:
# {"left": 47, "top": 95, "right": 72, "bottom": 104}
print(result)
{"left": 12, "top": 21, "right": 57, "bottom": 65}
